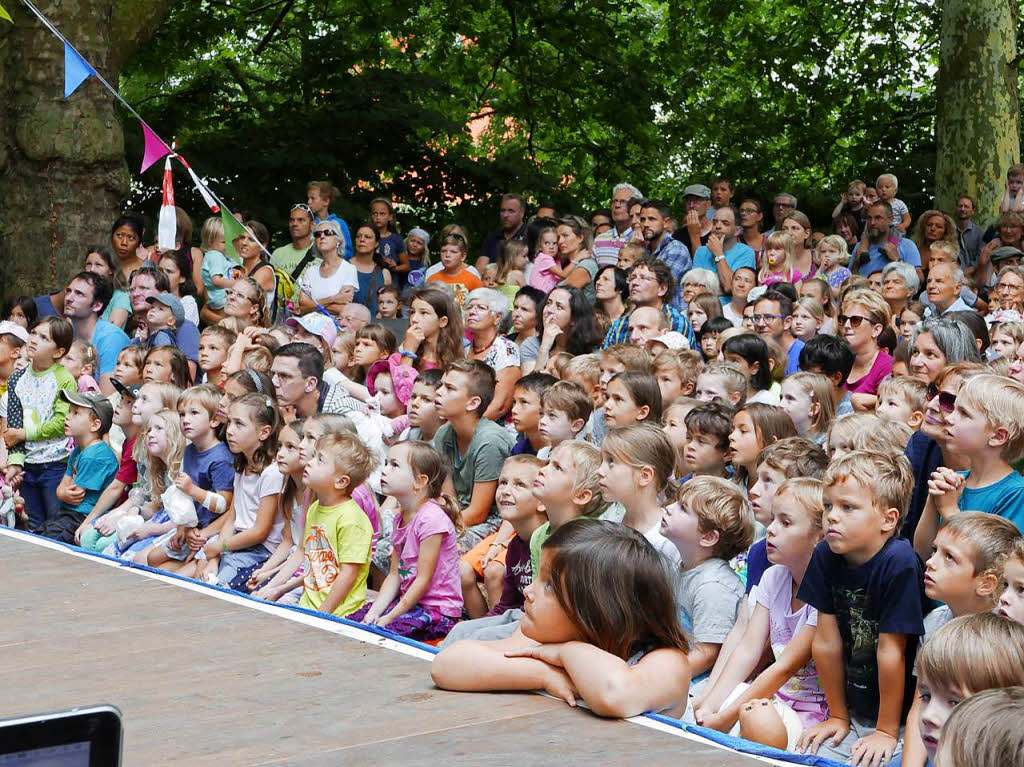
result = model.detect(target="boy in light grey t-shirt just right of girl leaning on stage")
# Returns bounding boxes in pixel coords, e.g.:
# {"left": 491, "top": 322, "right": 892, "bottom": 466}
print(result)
{"left": 662, "top": 476, "right": 754, "bottom": 676}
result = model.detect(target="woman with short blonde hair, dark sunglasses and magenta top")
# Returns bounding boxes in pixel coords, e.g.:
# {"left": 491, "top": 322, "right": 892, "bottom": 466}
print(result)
{"left": 836, "top": 290, "right": 893, "bottom": 411}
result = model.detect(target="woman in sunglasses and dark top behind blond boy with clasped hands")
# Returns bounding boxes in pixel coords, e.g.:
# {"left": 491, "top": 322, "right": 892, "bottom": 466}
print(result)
{"left": 900, "top": 363, "right": 988, "bottom": 541}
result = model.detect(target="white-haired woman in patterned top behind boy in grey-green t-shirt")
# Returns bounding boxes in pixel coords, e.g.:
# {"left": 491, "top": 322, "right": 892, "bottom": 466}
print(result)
{"left": 465, "top": 288, "right": 520, "bottom": 421}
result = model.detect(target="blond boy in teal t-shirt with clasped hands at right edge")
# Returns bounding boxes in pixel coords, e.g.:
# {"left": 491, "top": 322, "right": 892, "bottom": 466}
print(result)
{"left": 913, "top": 374, "right": 1024, "bottom": 559}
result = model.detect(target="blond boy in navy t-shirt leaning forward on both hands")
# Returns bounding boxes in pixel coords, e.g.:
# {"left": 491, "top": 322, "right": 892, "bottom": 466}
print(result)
{"left": 798, "top": 451, "right": 926, "bottom": 765}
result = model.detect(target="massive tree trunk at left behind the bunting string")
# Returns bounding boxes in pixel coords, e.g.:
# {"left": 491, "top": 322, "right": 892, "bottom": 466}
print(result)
{"left": 0, "top": 0, "right": 174, "bottom": 296}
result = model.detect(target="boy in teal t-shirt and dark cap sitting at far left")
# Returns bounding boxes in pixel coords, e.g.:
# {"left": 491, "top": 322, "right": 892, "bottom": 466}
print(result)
{"left": 40, "top": 389, "right": 118, "bottom": 544}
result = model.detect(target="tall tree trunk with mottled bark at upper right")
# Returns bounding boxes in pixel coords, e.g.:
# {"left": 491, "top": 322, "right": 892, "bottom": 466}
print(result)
{"left": 935, "top": 0, "right": 1020, "bottom": 221}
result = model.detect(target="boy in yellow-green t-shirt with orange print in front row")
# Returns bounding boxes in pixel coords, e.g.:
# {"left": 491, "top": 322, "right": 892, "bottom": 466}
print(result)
{"left": 299, "top": 434, "right": 375, "bottom": 617}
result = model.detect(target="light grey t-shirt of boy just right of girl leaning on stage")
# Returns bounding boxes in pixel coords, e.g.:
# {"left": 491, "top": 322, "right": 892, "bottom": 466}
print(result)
{"left": 677, "top": 558, "right": 743, "bottom": 644}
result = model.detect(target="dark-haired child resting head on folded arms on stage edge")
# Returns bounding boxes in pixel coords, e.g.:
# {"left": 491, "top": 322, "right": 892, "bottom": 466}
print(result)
{"left": 431, "top": 519, "right": 690, "bottom": 717}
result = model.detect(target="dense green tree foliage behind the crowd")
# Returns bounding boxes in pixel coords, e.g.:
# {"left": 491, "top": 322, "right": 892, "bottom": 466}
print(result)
{"left": 122, "top": 0, "right": 939, "bottom": 239}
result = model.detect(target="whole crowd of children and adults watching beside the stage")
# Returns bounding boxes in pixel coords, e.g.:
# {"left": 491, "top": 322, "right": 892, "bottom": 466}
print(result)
{"left": 0, "top": 173, "right": 1024, "bottom": 767}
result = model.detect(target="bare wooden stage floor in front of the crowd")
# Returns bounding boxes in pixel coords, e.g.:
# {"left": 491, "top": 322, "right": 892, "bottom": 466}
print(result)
{"left": 0, "top": 531, "right": 760, "bottom": 767}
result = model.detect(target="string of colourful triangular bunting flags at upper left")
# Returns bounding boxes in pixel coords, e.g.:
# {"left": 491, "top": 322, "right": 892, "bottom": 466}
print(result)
{"left": 14, "top": 0, "right": 341, "bottom": 330}
